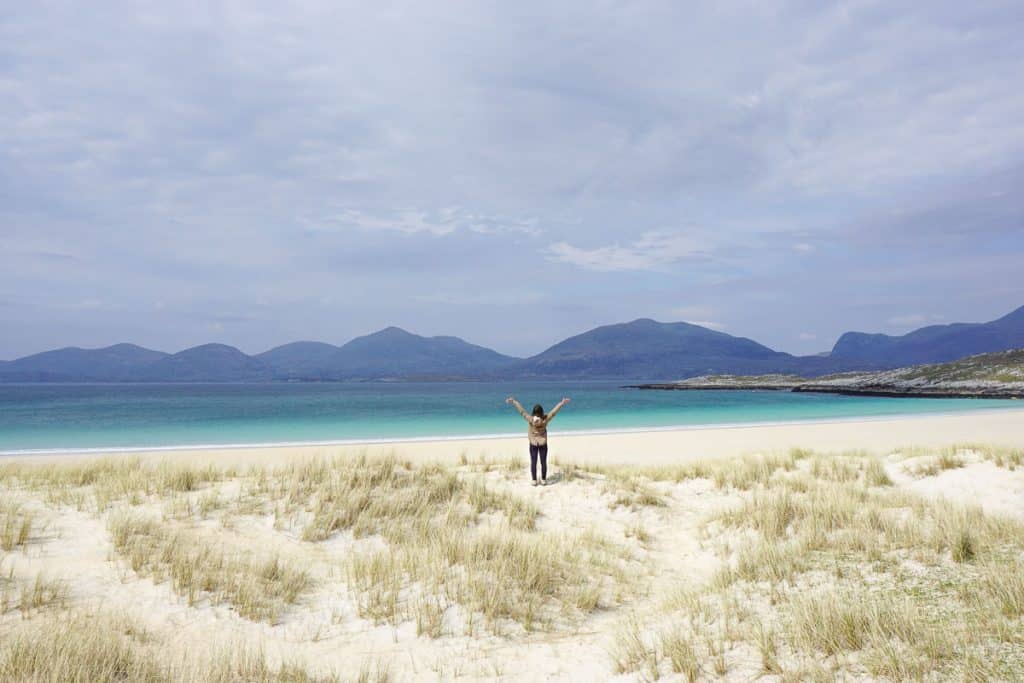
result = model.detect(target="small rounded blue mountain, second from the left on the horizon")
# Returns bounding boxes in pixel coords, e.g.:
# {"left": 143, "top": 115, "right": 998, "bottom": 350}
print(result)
{"left": 132, "top": 344, "right": 271, "bottom": 382}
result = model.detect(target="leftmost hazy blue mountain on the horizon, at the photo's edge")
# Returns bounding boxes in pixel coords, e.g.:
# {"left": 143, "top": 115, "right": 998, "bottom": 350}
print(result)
{"left": 0, "top": 344, "right": 167, "bottom": 382}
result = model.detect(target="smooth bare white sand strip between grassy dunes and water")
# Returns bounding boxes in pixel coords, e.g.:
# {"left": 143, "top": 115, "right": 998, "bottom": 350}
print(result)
{"left": 9, "top": 405, "right": 1024, "bottom": 466}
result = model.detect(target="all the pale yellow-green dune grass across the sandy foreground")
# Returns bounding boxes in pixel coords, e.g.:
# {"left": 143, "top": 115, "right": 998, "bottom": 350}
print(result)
{"left": 0, "top": 444, "right": 1024, "bottom": 682}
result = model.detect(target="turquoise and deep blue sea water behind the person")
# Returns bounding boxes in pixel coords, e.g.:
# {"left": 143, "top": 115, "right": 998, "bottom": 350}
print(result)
{"left": 0, "top": 381, "right": 1021, "bottom": 453}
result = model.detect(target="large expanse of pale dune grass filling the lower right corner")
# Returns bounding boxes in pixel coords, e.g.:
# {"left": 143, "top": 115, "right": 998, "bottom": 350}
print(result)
{"left": 612, "top": 452, "right": 1024, "bottom": 680}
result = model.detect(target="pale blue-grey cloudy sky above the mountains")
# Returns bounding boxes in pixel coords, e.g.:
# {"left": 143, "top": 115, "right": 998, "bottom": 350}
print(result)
{"left": 0, "top": 0, "right": 1024, "bottom": 359}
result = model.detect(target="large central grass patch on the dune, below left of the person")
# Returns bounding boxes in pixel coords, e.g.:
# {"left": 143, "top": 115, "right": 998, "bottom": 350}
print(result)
{"left": 254, "top": 458, "right": 626, "bottom": 637}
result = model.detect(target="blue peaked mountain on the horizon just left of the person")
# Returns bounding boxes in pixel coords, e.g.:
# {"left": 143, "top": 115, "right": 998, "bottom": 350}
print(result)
{"left": 329, "top": 327, "right": 518, "bottom": 379}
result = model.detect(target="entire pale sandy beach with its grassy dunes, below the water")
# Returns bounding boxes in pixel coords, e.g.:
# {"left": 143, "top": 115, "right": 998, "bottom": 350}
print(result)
{"left": 0, "top": 410, "right": 1024, "bottom": 681}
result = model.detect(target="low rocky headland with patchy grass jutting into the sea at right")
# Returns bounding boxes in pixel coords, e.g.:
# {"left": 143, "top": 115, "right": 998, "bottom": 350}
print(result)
{"left": 628, "top": 349, "right": 1024, "bottom": 398}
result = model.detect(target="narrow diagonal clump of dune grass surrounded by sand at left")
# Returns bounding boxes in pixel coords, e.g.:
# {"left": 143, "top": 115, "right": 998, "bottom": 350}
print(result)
{"left": 109, "top": 513, "right": 312, "bottom": 624}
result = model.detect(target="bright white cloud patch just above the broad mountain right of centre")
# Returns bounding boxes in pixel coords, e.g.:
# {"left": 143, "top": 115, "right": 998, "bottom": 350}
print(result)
{"left": 547, "top": 231, "right": 703, "bottom": 272}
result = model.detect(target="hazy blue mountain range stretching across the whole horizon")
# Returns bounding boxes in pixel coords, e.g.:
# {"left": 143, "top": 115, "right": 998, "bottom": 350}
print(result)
{"left": 0, "top": 306, "right": 1024, "bottom": 382}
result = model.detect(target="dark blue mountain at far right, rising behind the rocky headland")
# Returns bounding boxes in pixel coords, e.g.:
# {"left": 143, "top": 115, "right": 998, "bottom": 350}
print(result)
{"left": 830, "top": 306, "right": 1024, "bottom": 368}
